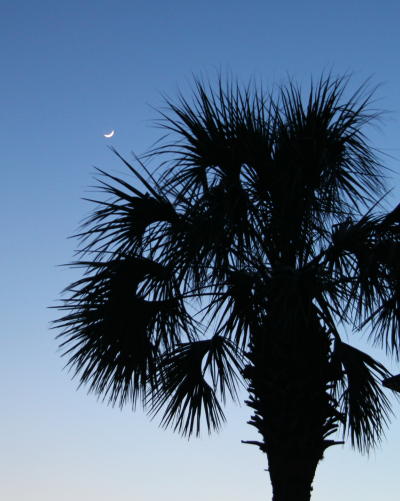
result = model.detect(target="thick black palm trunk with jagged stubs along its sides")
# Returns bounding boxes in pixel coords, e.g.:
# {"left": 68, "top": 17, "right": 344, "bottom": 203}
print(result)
{"left": 246, "top": 302, "right": 338, "bottom": 501}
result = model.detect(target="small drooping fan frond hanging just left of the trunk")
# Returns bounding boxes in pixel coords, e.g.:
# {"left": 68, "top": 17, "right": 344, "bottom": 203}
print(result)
{"left": 148, "top": 336, "right": 243, "bottom": 436}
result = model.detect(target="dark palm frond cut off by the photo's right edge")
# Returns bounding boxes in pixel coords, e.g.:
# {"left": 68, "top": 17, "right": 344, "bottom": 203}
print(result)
{"left": 327, "top": 208, "right": 400, "bottom": 356}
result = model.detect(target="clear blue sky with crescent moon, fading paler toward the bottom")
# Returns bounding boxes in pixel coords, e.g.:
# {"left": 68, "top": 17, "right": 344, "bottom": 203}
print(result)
{"left": 0, "top": 0, "right": 400, "bottom": 501}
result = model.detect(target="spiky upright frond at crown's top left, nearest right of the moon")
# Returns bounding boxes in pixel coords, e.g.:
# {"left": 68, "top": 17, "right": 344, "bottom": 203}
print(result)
{"left": 151, "top": 80, "right": 269, "bottom": 194}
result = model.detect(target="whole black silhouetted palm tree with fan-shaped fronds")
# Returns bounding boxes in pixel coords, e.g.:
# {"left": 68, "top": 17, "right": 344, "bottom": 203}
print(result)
{"left": 57, "top": 77, "right": 400, "bottom": 501}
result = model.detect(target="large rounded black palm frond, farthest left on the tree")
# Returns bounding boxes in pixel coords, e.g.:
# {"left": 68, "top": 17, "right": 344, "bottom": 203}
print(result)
{"left": 55, "top": 256, "right": 194, "bottom": 405}
